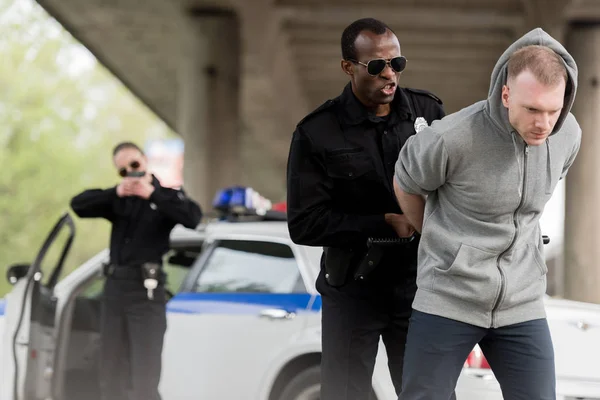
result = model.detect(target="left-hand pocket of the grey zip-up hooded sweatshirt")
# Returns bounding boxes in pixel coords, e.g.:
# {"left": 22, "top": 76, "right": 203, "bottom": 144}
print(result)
{"left": 433, "top": 244, "right": 500, "bottom": 309}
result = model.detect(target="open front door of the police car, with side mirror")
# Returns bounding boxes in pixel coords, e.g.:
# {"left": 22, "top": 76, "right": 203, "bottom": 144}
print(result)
{"left": 0, "top": 214, "right": 75, "bottom": 400}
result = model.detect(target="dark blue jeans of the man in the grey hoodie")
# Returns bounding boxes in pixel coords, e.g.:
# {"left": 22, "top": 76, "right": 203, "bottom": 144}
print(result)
{"left": 399, "top": 310, "right": 556, "bottom": 400}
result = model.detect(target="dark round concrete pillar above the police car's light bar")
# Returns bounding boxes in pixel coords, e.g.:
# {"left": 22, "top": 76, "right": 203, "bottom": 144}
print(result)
{"left": 178, "top": 9, "right": 240, "bottom": 210}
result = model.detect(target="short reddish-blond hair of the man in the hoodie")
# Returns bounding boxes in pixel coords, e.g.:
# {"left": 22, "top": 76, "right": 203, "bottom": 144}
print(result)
{"left": 507, "top": 45, "right": 568, "bottom": 86}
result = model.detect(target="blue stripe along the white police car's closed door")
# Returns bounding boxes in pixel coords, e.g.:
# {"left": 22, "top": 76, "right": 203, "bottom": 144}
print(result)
{"left": 167, "top": 293, "right": 321, "bottom": 314}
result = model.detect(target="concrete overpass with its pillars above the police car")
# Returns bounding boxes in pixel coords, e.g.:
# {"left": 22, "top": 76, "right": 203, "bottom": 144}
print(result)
{"left": 37, "top": 0, "right": 600, "bottom": 303}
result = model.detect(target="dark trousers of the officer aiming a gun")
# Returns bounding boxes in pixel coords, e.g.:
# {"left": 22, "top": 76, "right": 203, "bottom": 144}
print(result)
{"left": 100, "top": 275, "right": 167, "bottom": 400}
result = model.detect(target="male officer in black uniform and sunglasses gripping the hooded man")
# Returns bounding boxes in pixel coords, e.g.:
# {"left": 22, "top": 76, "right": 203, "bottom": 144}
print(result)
{"left": 287, "top": 18, "right": 444, "bottom": 400}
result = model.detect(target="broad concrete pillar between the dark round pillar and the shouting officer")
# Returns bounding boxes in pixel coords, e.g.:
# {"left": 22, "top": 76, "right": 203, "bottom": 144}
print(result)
{"left": 238, "top": 0, "right": 309, "bottom": 201}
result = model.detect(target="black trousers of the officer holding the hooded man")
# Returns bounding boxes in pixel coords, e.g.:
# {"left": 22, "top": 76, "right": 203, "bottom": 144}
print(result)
{"left": 316, "top": 252, "right": 416, "bottom": 400}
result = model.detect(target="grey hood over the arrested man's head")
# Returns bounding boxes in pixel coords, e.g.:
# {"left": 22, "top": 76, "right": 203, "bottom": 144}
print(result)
{"left": 487, "top": 28, "right": 577, "bottom": 135}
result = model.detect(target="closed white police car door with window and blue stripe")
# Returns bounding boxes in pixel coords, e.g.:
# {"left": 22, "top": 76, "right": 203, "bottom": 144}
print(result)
{"left": 160, "top": 236, "right": 318, "bottom": 400}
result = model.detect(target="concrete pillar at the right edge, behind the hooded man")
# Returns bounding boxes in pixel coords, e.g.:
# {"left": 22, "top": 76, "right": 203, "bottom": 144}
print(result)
{"left": 565, "top": 25, "right": 600, "bottom": 303}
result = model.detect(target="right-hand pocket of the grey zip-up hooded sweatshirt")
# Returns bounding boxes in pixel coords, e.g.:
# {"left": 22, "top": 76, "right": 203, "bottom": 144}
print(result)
{"left": 501, "top": 245, "right": 548, "bottom": 309}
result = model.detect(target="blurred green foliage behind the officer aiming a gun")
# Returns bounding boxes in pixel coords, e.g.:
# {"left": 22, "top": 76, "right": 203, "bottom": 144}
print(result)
{"left": 0, "top": 0, "right": 173, "bottom": 297}
